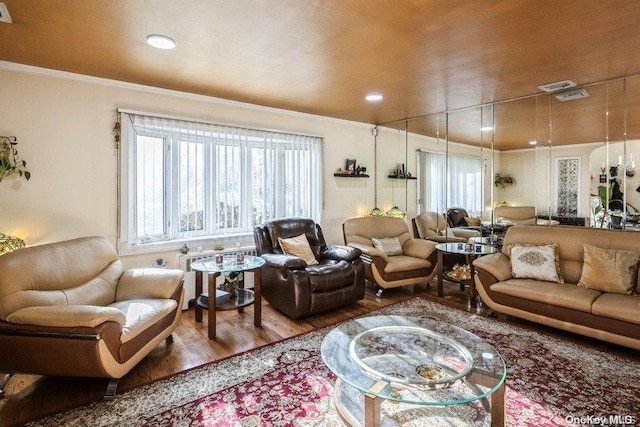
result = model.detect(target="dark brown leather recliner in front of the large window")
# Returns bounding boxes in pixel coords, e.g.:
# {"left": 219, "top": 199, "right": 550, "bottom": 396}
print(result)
{"left": 253, "top": 218, "right": 365, "bottom": 319}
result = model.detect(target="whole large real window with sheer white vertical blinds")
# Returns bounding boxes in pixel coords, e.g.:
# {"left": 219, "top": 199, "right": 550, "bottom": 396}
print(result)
{"left": 119, "top": 111, "right": 322, "bottom": 252}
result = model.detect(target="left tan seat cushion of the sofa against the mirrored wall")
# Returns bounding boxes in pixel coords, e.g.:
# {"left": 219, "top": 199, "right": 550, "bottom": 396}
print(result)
{"left": 491, "top": 279, "right": 602, "bottom": 313}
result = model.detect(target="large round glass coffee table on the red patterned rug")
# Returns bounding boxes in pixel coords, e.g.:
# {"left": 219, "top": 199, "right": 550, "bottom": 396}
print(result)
{"left": 321, "top": 316, "right": 507, "bottom": 427}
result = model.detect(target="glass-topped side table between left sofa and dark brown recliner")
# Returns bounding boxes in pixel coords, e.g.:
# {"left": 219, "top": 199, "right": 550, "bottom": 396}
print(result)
{"left": 191, "top": 255, "right": 264, "bottom": 339}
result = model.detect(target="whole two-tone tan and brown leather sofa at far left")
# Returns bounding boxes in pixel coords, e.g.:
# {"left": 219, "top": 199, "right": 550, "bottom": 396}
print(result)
{"left": 0, "top": 237, "right": 184, "bottom": 398}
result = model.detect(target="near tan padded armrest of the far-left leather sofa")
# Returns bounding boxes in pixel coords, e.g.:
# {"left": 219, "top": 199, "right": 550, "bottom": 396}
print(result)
{"left": 7, "top": 305, "right": 127, "bottom": 328}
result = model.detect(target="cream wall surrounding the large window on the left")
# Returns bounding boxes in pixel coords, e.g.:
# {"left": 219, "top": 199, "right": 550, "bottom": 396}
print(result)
{"left": 0, "top": 62, "right": 374, "bottom": 267}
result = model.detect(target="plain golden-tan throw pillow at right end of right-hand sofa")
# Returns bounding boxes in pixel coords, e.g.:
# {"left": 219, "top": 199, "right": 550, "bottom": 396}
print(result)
{"left": 578, "top": 245, "right": 640, "bottom": 295}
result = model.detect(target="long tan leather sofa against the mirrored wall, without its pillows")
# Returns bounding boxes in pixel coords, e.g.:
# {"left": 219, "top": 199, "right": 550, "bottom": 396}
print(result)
{"left": 473, "top": 226, "right": 640, "bottom": 349}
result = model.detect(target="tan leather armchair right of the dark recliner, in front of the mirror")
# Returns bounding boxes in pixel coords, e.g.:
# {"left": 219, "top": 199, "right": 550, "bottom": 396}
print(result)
{"left": 342, "top": 217, "right": 437, "bottom": 296}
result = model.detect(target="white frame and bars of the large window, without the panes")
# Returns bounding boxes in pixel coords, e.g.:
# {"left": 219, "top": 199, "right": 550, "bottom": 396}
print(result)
{"left": 118, "top": 109, "right": 324, "bottom": 255}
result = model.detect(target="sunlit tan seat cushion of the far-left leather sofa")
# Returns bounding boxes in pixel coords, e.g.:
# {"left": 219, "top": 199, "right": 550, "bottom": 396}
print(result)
{"left": 109, "top": 299, "right": 178, "bottom": 343}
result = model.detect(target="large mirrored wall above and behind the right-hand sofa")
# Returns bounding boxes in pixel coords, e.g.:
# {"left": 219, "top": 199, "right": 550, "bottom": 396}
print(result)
{"left": 376, "top": 76, "right": 640, "bottom": 234}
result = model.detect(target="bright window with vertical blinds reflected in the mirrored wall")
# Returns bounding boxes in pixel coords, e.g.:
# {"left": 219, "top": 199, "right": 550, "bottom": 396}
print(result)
{"left": 418, "top": 151, "right": 482, "bottom": 213}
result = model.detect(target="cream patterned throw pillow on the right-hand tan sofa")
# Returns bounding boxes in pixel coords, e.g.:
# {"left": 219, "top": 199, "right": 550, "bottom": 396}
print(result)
{"left": 510, "top": 243, "right": 564, "bottom": 283}
